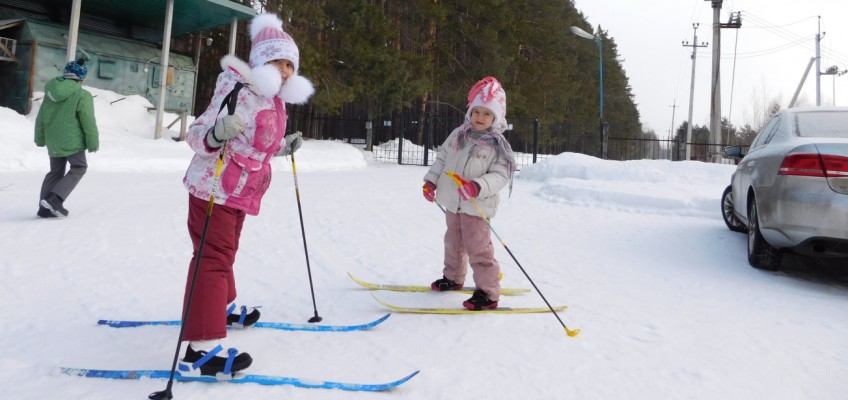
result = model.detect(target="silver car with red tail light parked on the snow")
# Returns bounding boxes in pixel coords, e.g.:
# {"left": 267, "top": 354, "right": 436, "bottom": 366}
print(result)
{"left": 721, "top": 107, "right": 848, "bottom": 270}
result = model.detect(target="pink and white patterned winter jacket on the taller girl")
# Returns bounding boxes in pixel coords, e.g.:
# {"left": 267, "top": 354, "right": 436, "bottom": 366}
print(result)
{"left": 183, "top": 56, "right": 312, "bottom": 215}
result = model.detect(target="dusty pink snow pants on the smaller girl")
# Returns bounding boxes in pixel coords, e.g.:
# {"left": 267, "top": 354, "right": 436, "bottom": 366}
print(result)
{"left": 443, "top": 211, "right": 501, "bottom": 301}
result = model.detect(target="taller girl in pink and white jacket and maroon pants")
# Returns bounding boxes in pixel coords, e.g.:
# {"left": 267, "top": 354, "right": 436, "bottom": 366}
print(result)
{"left": 180, "top": 14, "right": 314, "bottom": 375}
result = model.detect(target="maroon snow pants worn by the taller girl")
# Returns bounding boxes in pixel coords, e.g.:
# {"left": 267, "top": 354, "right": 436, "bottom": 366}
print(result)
{"left": 183, "top": 195, "right": 245, "bottom": 341}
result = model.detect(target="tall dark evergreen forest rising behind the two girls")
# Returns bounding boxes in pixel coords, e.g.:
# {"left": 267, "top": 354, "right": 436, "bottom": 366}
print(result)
{"left": 189, "top": 0, "right": 644, "bottom": 152}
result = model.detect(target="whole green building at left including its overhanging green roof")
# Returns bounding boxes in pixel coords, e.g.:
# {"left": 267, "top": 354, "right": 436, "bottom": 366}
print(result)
{"left": 0, "top": 0, "right": 255, "bottom": 119}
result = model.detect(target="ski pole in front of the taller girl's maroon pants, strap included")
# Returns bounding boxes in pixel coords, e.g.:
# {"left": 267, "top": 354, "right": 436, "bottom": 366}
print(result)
{"left": 147, "top": 82, "right": 244, "bottom": 400}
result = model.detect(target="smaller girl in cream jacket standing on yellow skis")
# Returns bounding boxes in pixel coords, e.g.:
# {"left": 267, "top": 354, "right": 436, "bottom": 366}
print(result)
{"left": 423, "top": 77, "right": 515, "bottom": 310}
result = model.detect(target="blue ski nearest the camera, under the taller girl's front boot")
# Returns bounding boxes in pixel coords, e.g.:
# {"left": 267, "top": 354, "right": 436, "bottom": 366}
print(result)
{"left": 60, "top": 368, "right": 420, "bottom": 392}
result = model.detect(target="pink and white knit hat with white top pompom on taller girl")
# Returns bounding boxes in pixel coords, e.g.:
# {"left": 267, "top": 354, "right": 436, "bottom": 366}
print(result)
{"left": 250, "top": 14, "right": 300, "bottom": 73}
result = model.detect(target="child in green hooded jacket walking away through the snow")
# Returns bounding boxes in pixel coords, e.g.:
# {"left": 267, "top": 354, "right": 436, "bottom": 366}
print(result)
{"left": 35, "top": 59, "right": 100, "bottom": 218}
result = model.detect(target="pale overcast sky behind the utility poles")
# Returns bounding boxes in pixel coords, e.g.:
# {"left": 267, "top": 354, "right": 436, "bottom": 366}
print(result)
{"left": 574, "top": 0, "right": 848, "bottom": 138}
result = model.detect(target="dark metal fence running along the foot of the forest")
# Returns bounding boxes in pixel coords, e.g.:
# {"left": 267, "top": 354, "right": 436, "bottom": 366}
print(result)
{"left": 289, "top": 112, "right": 744, "bottom": 169}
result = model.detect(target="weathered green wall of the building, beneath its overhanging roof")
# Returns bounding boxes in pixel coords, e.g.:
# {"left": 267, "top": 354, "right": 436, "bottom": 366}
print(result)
{"left": 0, "top": 16, "right": 196, "bottom": 114}
